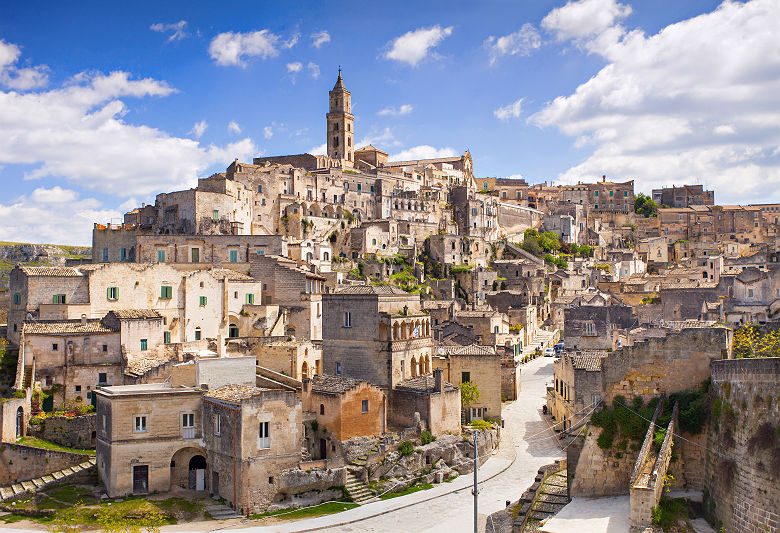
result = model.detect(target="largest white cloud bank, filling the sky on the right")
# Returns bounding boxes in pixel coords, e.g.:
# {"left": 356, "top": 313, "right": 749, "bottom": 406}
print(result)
{"left": 530, "top": 0, "right": 780, "bottom": 202}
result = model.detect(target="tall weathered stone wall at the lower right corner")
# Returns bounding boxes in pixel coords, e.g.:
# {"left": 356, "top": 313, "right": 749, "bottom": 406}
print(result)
{"left": 704, "top": 358, "right": 780, "bottom": 533}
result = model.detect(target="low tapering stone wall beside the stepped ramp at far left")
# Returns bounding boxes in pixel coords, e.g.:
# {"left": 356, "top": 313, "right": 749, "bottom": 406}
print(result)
{"left": 0, "top": 444, "right": 88, "bottom": 485}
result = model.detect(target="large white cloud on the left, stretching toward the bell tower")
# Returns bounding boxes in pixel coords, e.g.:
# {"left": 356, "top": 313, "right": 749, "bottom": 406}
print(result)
{"left": 0, "top": 45, "right": 258, "bottom": 198}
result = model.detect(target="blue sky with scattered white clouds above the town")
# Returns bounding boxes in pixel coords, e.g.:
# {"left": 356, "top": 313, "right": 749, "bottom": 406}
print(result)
{"left": 0, "top": 0, "right": 780, "bottom": 245}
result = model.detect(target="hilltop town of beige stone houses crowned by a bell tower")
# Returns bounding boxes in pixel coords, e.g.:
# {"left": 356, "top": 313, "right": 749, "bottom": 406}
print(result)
{"left": 0, "top": 73, "right": 780, "bottom": 532}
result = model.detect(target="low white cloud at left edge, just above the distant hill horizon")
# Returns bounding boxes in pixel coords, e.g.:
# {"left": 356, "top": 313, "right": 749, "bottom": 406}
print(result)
{"left": 0, "top": 186, "right": 122, "bottom": 246}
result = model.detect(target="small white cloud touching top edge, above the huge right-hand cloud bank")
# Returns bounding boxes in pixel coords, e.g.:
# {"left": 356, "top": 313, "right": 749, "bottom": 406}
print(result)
{"left": 542, "top": 0, "right": 631, "bottom": 41}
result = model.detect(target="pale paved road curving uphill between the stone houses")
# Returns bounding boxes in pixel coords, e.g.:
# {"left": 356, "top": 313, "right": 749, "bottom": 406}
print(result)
{"left": 231, "top": 357, "right": 563, "bottom": 533}
